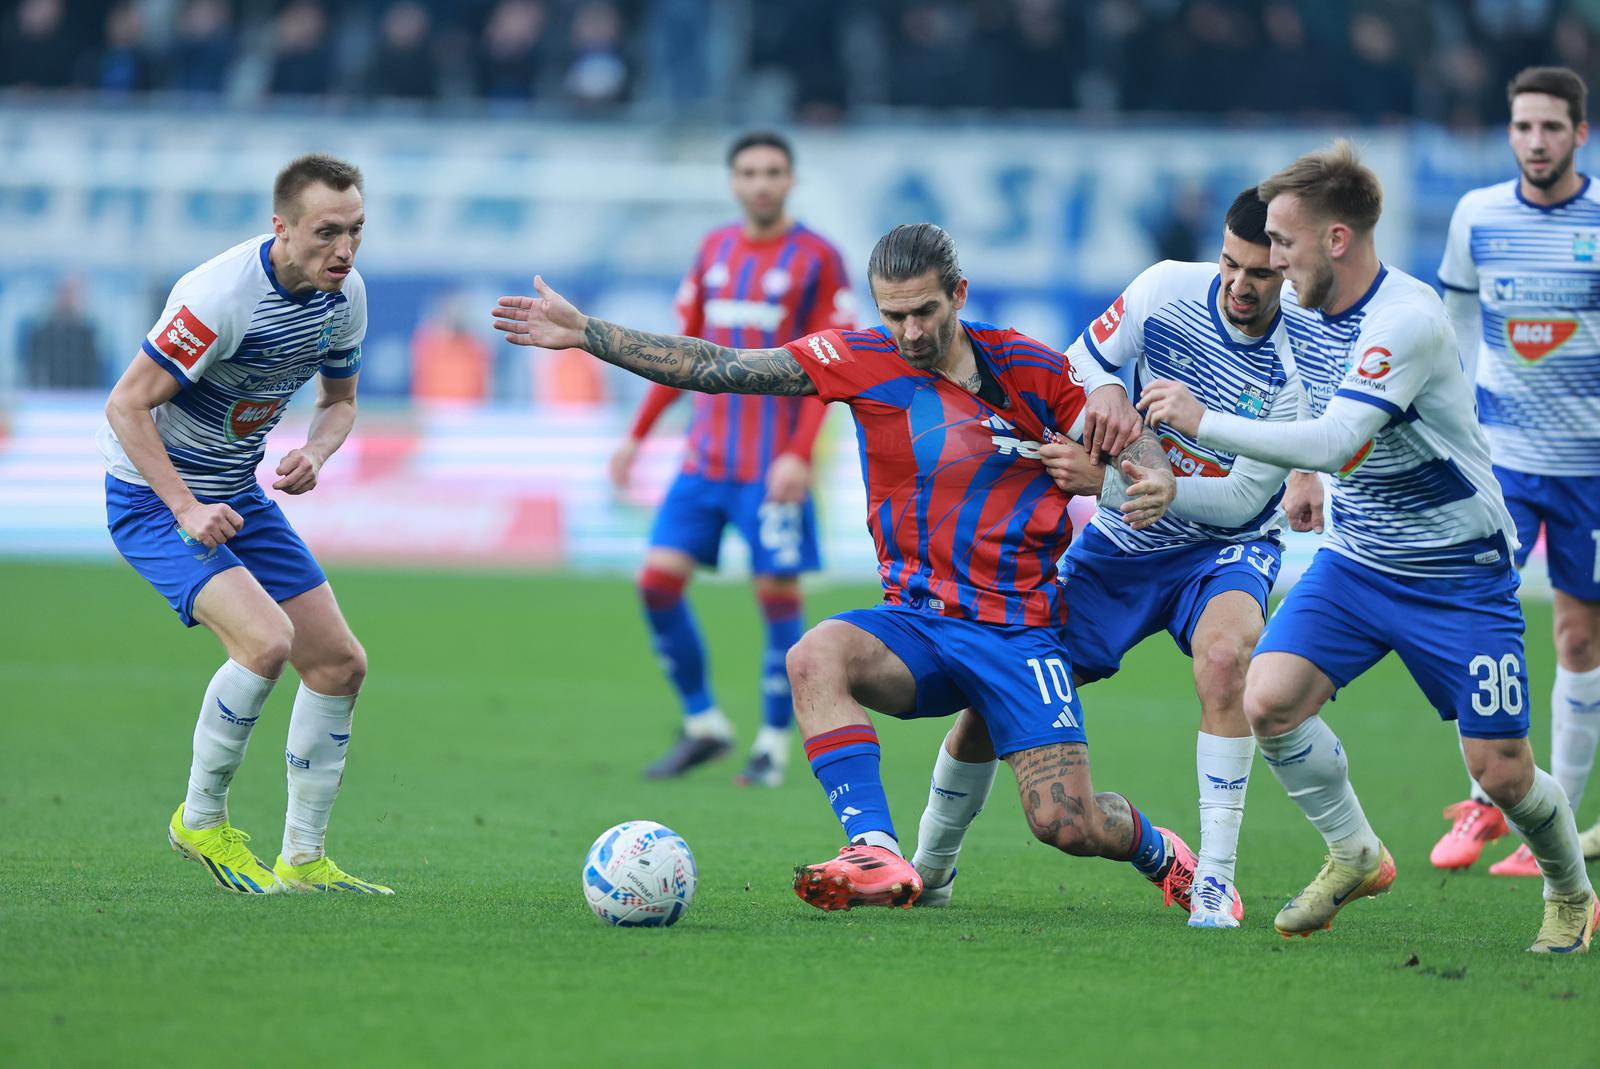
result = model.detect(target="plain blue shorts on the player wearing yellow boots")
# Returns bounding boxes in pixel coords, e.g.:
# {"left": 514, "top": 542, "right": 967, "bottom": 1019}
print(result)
{"left": 106, "top": 475, "right": 328, "bottom": 627}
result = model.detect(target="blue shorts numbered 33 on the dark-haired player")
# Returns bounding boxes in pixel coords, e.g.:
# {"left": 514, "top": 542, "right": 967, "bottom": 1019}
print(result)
{"left": 1061, "top": 526, "right": 1283, "bottom": 683}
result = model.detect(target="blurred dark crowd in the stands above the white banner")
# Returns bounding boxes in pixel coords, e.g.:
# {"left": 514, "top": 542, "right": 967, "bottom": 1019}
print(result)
{"left": 9, "top": 0, "right": 1600, "bottom": 128}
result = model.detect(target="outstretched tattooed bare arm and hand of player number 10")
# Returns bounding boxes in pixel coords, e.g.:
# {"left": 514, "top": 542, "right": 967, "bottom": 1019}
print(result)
{"left": 494, "top": 277, "right": 816, "bottom": 394}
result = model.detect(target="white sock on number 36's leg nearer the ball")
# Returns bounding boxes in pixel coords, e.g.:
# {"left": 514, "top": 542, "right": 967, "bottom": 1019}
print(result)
{"left": 1256, "top": 717, "right": 1379, "bottom": 869}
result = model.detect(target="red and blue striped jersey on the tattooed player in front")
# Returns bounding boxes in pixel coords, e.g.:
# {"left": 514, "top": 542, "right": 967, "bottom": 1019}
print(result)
{"left": 786, "top": 322, "right": 1085, "bottom": 626}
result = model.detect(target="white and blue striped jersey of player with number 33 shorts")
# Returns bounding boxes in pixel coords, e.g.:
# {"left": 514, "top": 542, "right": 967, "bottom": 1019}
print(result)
{"left": 1067, "top": 259, "right": 1299, "bottom": 552}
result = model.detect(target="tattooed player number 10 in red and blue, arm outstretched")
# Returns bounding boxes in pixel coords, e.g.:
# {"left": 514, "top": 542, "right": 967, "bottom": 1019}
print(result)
{"left": 494, "top": 222, "right": 1194, "bottom": 911}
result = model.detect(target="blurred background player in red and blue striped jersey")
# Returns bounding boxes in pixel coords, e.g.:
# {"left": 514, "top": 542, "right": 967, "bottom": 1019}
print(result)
{"left": 611, "top": 131, "right": 854, "bottom": 787}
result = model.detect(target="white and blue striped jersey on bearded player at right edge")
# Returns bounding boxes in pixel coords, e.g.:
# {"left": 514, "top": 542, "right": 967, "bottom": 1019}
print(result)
{"left": 1438, "top": 178, "right": 1600, "bottom": 475}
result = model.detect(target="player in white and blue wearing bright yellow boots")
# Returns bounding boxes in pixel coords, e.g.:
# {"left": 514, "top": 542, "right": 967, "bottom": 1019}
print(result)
{"left": 99, "top": 155, "right": 394, "bottom": 895}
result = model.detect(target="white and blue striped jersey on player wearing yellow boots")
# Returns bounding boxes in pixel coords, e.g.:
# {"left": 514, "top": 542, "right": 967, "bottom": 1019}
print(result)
{"left": 96, "top": 234, "right": 366, "bottom": 498}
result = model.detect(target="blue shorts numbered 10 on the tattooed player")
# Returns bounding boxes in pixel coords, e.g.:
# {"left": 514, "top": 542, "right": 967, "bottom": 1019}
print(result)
{"left": 834, "top": 605, "right": 1088, "bottom": 757}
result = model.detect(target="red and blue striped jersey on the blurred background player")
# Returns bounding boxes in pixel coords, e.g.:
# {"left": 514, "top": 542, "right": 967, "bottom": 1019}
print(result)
{"left": 632, "top": 222, "right": 856, "bottom": 483}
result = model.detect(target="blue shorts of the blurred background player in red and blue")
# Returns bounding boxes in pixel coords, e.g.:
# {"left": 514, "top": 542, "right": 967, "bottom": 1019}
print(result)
{"left": 650, "top": 475, "right": 821, "bottom": 576}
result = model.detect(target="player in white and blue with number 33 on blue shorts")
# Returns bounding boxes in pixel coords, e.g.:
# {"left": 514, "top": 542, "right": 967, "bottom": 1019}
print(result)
{"left": 912, "top": 186, "right": 1299, "bottom": 928}
